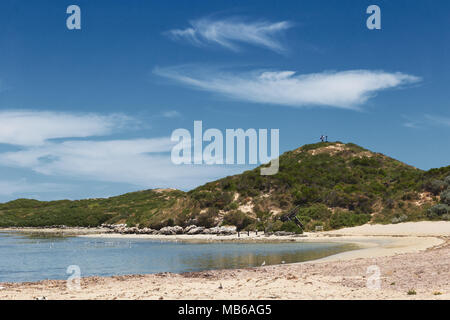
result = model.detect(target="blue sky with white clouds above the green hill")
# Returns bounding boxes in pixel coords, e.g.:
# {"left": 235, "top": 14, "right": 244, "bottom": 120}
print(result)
{"left": 0, "top": 0, "right": 450, "bottom": 201}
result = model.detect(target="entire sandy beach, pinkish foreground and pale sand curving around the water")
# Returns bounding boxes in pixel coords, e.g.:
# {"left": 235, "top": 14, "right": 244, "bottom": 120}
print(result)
{"left": 0, "top": 221, "right": 450, "bottom": 299}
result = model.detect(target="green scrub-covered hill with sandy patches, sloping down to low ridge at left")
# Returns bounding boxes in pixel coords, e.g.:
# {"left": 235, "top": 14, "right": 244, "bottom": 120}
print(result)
{"left": 0, "top": 142, "right": 450, "bottom": 231}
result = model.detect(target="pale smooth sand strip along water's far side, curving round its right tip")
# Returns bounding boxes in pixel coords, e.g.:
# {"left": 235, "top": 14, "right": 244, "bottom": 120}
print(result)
{"left": 0, "top": 221, "right": 450, "bottom": 263}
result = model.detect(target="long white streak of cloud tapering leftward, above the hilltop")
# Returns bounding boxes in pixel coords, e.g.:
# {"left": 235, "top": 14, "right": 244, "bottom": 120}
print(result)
{"left": 154, "top": 66, "right": 420, "bottom": 109}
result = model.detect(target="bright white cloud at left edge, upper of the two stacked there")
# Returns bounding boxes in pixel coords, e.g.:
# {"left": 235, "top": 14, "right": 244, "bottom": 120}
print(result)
{"left": 0, "top": 111, "right": 130, "bottom": 146}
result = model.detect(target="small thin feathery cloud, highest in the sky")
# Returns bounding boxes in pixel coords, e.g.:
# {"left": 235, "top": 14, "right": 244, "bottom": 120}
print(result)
{"left": 167, "top": 17, "right": 292, "bottom": 52}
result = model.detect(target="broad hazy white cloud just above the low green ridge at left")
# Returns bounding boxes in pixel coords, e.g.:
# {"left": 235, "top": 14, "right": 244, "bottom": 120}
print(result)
{"left": 0, "top": 137, "right": 242, "bottom": 188}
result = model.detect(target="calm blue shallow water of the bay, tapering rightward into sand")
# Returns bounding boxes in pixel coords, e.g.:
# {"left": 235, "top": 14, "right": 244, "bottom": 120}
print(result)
{"left": 0, "top": 232, "right": 356, "bottom": 282}
